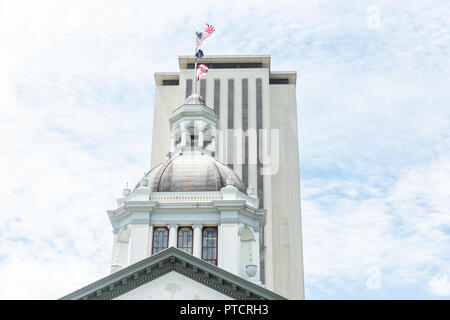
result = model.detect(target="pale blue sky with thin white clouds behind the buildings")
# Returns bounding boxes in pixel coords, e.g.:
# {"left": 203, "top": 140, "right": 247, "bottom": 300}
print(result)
{"left": 0, "top": 0, "right": 450, "bottom": 299}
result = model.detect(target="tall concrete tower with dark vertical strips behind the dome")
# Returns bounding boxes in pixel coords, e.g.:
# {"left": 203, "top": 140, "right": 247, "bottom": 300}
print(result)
{"left": 151, "top": 55, "right": 304, "bottom": 299}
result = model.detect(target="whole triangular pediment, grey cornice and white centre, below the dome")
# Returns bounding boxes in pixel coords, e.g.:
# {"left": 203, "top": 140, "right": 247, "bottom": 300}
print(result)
{"left": 61, "top": 247, "right": 285, "bottom": 300}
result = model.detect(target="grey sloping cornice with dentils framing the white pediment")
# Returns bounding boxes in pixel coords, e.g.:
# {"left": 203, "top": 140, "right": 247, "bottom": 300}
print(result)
{"left": 61, "top": 247, "right": 285, "bottom": 300}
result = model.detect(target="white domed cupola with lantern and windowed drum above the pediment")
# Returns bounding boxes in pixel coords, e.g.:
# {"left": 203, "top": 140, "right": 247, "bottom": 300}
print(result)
{"left": 108, "top": 90, "right": 266, "bottom": 284}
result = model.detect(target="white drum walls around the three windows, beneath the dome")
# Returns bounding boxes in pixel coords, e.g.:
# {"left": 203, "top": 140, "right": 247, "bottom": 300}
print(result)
{"left": 108, "top": 185, "right": 265, "bottom": 283}
